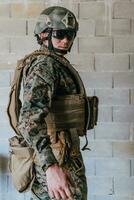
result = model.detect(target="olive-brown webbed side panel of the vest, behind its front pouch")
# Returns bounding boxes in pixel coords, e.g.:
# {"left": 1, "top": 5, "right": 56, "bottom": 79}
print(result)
{"left": 45, "top": 94, "right": 85, "bottom": 132}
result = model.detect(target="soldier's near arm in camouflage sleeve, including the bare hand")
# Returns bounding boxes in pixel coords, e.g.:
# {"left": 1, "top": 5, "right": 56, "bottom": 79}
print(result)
{"left": 18, "top": 56, "right": 72, "bottom": 200}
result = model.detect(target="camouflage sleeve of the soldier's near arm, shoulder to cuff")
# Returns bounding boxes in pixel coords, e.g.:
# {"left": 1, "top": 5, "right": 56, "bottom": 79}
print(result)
{"left": 18, "top": 57, "right": 57, "bottom": 169}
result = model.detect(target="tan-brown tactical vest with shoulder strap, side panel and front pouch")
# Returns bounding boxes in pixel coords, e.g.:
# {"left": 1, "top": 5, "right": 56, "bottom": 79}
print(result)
{"left": 7, "top": 50, "right": 98, "bottom": 139}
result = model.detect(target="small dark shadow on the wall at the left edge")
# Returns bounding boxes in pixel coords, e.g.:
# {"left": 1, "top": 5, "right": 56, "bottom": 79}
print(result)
{"left": 0, "top": 154, "right": 9, "bottom": 173}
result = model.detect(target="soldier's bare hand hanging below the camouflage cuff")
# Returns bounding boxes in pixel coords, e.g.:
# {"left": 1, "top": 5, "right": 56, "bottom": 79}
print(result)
{"left": 46, "top": 164, "right": 73, "bottom": 200}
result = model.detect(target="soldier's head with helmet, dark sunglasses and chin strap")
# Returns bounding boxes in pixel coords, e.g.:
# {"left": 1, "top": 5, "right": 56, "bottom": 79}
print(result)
{"left": 34, "top": 6, "right": 78, "bottom": 54}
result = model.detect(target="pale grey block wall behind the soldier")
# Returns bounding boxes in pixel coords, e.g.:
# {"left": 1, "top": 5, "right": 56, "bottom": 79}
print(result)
{"left": 0, "top": 0, "right": 134, "bottom": 200}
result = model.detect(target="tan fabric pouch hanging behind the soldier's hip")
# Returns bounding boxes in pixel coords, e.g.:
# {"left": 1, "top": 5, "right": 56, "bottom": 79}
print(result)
{"left": 9, "top": 136, "right": 35, "bottom": 192}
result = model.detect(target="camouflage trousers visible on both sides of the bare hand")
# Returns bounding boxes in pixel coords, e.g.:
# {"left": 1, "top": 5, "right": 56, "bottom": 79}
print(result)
{"left": 32, "top": 153, "right": 87, "bottom": 200}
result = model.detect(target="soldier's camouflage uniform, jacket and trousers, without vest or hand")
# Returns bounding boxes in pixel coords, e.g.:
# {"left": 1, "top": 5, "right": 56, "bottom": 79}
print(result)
{"left": 18, "top": 45, "right": 87, "bottom": 200}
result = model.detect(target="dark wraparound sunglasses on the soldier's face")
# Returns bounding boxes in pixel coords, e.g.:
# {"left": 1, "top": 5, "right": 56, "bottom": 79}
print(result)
{"left": 52, "top": 30, "right": 76, "bottom": 40}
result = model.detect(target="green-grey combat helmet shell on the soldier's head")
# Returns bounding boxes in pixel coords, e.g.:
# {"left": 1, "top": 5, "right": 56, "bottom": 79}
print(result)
{"left": 34, "top": 6, "right": 78, "bottom": 35}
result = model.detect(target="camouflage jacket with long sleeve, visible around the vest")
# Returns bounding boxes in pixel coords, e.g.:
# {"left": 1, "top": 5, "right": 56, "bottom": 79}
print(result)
{"left": 18, "top": 46, "right": 78, "bottom": 169}
